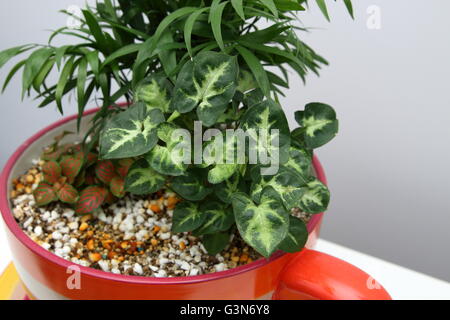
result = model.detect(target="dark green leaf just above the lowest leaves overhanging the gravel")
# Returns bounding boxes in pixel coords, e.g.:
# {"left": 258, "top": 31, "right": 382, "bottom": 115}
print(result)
{"left": 171, "top": 169, "right": 212, "bottom": 201}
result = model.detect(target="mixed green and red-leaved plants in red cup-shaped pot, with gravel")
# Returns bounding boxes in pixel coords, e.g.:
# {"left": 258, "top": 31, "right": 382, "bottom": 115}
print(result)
{"left": 0, "top": 0, "right": 389, "bottom": 299}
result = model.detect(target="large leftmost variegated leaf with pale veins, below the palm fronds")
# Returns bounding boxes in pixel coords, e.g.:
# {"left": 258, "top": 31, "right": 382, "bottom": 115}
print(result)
{"left": 100, "top": 103, "right": 164, "bottom": 159}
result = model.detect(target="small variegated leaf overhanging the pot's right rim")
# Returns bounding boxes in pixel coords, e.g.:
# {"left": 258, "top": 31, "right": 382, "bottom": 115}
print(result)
{"left": 299, "top": 178, "right": 330, "bottom": 214}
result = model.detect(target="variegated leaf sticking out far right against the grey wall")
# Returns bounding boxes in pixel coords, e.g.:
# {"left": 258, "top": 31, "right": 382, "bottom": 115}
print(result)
{"left": 295, "top": 103, "right": 339, "bottom": 149}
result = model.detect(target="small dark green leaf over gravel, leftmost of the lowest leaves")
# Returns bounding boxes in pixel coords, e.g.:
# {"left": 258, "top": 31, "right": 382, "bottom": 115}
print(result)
{"left": 172, "top": 202, "right": 206, "bottom": 233}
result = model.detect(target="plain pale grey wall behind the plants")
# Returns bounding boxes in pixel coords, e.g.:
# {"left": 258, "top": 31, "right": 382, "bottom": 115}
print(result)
{"left": 0, "top": 0, "right": 450, "bottom": 280}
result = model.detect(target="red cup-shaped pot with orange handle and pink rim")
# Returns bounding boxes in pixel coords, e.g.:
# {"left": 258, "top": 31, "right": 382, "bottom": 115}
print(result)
{"left": 0, "top": 110, "right": 390, "bottom": 300}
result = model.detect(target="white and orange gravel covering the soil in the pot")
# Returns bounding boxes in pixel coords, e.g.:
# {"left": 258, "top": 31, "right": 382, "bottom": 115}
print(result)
{"left": 11, "top": 160, "right": 309, "bottom": 277}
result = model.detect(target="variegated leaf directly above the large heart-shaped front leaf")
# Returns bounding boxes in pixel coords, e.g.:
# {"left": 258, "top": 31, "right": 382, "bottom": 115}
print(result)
{"left": 251, "top": 167, "right": 306, "bottom": 210}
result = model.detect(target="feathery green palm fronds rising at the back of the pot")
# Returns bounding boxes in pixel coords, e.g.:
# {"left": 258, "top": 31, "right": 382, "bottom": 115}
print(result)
{"left": 0, "top": 0, "right": 352, "bottom": 131}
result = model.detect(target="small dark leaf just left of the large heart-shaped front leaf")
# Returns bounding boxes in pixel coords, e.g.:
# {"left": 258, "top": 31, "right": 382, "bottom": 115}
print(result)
{"left": 194, "top": 201, "right": 234, "bottom": 235}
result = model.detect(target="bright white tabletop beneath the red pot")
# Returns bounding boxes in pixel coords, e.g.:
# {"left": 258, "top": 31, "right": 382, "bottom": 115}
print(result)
{"left": 0, "top": 221, "right": 450, "bottom": 300}
